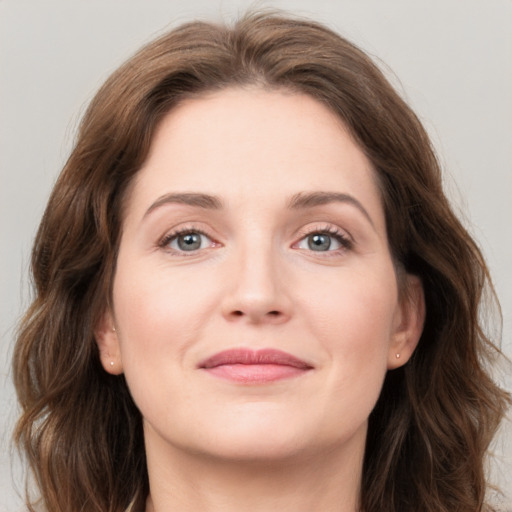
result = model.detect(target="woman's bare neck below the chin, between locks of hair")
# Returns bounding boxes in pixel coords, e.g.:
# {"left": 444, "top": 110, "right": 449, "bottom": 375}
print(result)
{"left": 146, "top": 428, "right": 364, "bottom": 512}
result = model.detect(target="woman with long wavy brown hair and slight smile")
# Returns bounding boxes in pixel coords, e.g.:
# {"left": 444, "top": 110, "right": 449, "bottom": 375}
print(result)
{"left": 14, "top": 15, "right": 509, "bottom": 512}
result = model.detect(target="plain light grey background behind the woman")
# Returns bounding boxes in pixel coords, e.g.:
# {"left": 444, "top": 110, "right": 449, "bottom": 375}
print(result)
{"left": 0, "top": 0, "right": 512, "bottom": 512}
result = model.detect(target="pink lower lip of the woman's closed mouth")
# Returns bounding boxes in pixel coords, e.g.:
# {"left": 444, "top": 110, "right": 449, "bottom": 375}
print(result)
{"left": 205, "top": 364, "right": 308, "bottom": 383}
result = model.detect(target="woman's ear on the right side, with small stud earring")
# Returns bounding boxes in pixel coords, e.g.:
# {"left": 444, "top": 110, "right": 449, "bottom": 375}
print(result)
{"left": 388, "top": 274, "right": 425, "bottom": 370}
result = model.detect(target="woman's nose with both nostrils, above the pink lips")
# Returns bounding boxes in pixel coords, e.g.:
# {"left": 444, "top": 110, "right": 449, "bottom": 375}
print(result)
{"left": 222, "top": 240, "right": 292, "bottom": 324}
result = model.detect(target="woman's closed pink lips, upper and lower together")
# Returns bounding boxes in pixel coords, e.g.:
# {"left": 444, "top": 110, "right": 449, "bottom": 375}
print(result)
{"left": 198, "top": 349, "right": 313, "bottom": 383}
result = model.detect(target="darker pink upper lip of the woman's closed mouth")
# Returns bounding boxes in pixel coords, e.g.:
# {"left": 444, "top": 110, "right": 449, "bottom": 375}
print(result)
{"left": 198, "top": 348, "right": 312, "bottom": 370}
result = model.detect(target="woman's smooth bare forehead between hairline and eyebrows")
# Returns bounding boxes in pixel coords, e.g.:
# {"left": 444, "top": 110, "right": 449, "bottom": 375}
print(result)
{"left": 122, "top": 88, "right": 382, "bottom": 228}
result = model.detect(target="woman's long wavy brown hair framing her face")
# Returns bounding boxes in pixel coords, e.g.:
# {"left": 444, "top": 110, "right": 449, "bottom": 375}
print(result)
{"left": 14, "top": 14, "right": 509, "bottom": 512}
